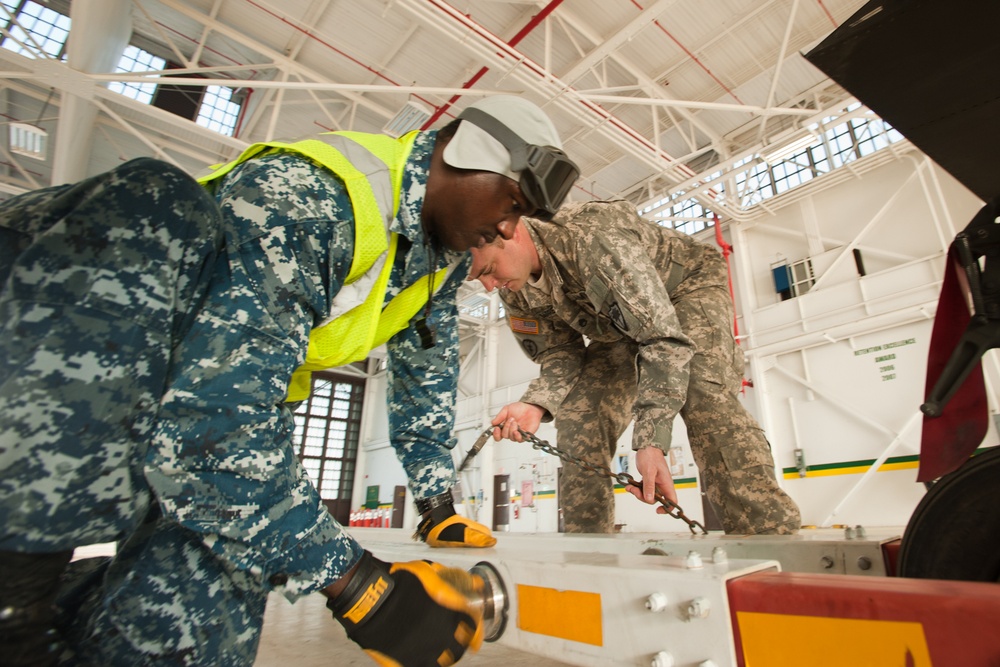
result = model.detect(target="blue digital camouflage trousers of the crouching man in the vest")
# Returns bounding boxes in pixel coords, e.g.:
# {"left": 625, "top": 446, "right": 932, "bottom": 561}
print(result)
{"left": 0, "top": 160, "right": 266, "bottom": 665}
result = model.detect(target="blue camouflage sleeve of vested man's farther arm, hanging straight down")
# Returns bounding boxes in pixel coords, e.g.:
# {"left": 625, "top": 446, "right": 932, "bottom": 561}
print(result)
{"left": 386, "top": 257, "right": 471, "bottom": 499}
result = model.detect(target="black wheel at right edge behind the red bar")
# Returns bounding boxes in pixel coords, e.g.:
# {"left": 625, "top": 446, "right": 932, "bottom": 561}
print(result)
{"left": 898, "top": 447, "right": 1000, "bottom": 582}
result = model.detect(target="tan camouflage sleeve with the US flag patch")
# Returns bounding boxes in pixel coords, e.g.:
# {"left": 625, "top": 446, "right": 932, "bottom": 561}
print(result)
{"left": 500, "top": 287, "right": 586, "bottom": 422}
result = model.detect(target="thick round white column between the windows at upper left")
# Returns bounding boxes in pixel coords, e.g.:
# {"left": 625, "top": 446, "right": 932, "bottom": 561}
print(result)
{"left": 52, "top": 0, "right": 132, "bottom": 185}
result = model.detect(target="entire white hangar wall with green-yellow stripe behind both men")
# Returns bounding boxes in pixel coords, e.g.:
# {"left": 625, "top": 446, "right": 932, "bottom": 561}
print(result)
{"left": 356, "top": 151, "right": 1000, "bottom": 532}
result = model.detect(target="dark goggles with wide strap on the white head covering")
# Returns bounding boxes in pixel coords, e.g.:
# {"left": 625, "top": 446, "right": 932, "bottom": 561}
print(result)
{"left": 458, "top": 108, "right": 580, "bottom": 220}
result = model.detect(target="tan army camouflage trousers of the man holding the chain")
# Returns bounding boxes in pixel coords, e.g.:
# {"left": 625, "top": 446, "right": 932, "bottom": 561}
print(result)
{"left": 555, "top": 287, "right": 800, "bottom": 535}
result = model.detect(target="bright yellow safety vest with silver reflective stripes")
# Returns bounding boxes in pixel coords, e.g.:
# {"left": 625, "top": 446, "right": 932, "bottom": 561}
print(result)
{"left": 198, "top": 131, "right": 449, "bottom": 401}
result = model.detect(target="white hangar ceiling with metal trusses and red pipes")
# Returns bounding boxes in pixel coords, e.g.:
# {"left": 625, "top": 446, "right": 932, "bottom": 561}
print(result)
{"left": 0, "top": 0, "right": 865, "bottom": 216}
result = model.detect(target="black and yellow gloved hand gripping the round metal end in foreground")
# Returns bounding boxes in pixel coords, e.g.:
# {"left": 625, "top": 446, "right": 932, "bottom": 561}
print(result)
{"left": 326, "top": 551, "right": 484, "bottom": 667}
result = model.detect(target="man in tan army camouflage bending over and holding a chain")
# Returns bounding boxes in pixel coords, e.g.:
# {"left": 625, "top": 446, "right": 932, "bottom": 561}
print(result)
{"left": 469, "top": 201, "right": 799, "bottom": 534}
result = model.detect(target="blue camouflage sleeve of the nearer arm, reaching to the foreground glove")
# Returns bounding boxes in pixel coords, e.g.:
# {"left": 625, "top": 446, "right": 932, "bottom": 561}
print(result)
{"left": 145, "top": 154, "right": 361, "bottom": 599}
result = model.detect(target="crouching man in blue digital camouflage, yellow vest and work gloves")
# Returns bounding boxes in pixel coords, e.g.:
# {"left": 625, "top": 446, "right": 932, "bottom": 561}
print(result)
{"left": 0, "top": 96, "right": 578, "bottom": 665}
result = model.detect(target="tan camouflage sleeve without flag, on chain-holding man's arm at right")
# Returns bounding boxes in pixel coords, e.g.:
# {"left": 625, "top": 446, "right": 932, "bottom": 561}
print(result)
{"left": 576, "top": 219, "right": 694, "bottom": 453}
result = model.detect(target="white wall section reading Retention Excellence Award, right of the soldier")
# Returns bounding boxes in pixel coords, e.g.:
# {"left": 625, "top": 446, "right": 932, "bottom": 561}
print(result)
{"left": 730, "top": 154, "right": 997, "bottom": 525}
